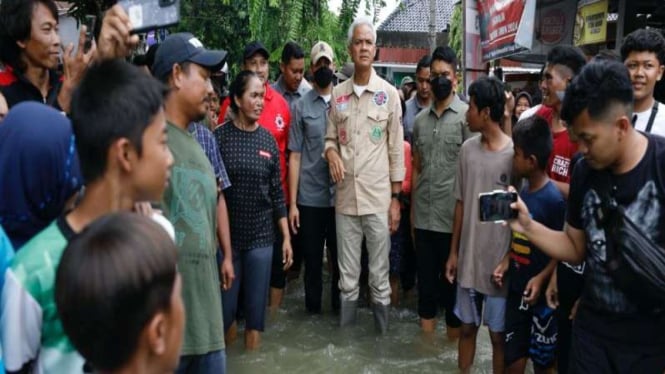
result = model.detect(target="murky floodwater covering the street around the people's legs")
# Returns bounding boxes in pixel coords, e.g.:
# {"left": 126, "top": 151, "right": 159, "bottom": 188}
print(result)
{"left": 226, "top": 274, "right": 491, "bottom": 374}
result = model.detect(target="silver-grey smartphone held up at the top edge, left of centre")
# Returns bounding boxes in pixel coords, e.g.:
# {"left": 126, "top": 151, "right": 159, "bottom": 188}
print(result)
{"left": 118, "top": 0, "right": 180, "bottom": 33}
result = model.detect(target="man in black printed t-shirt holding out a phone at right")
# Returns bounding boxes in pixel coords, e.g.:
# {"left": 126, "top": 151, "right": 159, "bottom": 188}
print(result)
{"left": 510, "top": 61, "right": 665, "bottom": 373}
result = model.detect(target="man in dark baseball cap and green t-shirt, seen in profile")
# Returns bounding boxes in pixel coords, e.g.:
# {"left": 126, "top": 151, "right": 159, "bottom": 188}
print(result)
{"left": 152, "top": 33, "right": 234, "bottom": 374}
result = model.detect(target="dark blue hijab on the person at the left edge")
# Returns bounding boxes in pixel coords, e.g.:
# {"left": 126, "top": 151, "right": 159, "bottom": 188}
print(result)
{"left": 0, "top": 102, "right": 82, "bottom": 251}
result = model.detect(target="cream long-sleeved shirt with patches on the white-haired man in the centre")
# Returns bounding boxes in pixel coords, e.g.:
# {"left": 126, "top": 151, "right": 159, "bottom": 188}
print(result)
{"left": 324, "top": 70, "right": 406, "bottom": 215}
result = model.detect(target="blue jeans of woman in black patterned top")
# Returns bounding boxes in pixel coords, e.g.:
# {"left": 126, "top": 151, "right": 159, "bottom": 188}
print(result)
{"left": 222, "top": 245, "right": 272, "bottom": 331}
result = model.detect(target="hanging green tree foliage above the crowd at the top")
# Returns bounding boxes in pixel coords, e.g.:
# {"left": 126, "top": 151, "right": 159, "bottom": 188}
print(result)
{"left": 66, "top": 0, "right": 385, "bottom": 75}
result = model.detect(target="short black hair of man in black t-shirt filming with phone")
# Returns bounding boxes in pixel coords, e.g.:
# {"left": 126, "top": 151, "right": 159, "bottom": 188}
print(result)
{"left": 561, "top": 60, "right": 633, "bottom": 124}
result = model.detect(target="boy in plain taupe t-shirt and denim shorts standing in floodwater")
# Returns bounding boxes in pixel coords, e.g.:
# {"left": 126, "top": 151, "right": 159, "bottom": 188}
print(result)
{"left": 446, "top": 77, "right": 514, "bottom": 372}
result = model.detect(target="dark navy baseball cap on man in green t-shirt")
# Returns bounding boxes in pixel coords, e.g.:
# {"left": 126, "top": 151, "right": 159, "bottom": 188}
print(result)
{"left": 152, "top": 32, "right": 227, "bottom": 78}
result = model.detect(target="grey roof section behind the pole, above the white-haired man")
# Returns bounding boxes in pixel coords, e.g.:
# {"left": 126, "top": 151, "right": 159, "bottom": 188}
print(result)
{"left": 379, "top": 0, "right": 456, "bottom": 32}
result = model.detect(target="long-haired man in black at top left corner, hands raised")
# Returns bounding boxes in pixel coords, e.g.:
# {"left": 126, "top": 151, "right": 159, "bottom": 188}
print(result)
{"left": 0, "top": 0, "right": 139, "bottom": 113}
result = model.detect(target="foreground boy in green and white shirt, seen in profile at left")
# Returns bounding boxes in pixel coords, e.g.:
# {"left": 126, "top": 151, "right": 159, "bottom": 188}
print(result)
{"left": 0, "top": 60, "right": 173, "bottom": 373}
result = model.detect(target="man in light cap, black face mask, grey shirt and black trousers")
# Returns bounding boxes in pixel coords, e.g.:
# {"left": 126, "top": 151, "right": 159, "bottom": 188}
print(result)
{"left": 289, "top": 42, "right": 339, "bottom": 313}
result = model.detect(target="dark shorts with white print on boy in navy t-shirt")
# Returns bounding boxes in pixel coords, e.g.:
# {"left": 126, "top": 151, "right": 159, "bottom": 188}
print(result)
{"left": 504, "top": 292, "right": 557, "bottom": 369}
